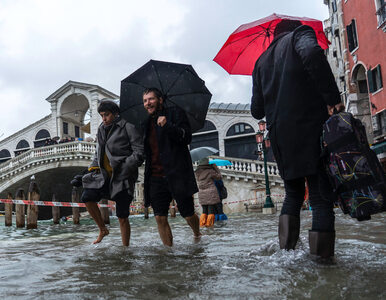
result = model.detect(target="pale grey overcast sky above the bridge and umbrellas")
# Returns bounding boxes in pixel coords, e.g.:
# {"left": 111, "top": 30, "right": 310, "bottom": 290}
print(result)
{"left": 0, "top": 0, "right": 328, "bottom": 140}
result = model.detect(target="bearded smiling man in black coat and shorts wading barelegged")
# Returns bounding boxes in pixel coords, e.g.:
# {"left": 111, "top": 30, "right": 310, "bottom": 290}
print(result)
{"left": 143, "top": 88, "right": 201, "bottom": 246}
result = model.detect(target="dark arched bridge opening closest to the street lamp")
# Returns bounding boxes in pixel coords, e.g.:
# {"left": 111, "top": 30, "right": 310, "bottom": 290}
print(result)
{"left": 224, "top": 123, "right": 258, "bottom": 159}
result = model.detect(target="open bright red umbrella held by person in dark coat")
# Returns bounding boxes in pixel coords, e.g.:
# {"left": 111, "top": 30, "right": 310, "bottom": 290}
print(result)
{"left": 213, "top": 14, "right": 330, "bottom": 75}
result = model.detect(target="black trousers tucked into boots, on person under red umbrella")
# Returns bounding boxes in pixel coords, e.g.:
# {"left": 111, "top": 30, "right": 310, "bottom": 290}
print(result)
{"left": 281, "top": 170, "right": 336, "bottom": 232}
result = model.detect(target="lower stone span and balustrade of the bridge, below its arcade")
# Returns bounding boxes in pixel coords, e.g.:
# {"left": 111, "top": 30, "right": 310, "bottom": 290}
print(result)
{"left": 0, "top": 141, "right": 284, "bottom": 213}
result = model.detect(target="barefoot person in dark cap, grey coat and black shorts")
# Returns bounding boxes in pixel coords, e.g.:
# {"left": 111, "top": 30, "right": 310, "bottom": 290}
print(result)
{"left": 81, "top": 101, "right": 144, "bottom": 246}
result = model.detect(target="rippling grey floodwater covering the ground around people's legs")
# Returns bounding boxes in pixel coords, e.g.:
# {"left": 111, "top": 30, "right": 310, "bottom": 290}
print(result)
{"left": 0, "top": 210, "right": 386, "bottom": 300}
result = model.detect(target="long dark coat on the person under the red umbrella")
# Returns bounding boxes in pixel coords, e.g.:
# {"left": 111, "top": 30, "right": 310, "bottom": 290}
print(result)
{"left": 251, "top": 26, "right": 340, "bottom": 180}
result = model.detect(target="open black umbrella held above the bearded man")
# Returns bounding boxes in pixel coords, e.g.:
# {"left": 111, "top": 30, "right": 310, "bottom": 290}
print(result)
{"left": 120, "top": 60, "right": 212, "bottom": 132}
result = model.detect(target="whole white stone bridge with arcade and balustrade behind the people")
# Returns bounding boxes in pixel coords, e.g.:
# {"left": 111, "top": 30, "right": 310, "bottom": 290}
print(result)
{"left": 0, "top": 81, "right": 283, "bottom": 218}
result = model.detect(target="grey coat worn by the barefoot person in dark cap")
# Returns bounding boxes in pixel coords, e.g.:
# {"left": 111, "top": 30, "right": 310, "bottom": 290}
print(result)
{"left": 83, "top": 119, "right": 144, "bottom": 198}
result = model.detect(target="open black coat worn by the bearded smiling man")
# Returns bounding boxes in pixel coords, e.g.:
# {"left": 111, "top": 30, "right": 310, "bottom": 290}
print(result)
{"left": 144, "top": 107, "right": 198, "bottom": 206}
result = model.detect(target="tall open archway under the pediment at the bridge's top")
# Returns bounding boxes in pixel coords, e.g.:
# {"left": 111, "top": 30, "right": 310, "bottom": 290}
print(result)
{"left": 59, "top": 93, "right": 90, "bottom": 141}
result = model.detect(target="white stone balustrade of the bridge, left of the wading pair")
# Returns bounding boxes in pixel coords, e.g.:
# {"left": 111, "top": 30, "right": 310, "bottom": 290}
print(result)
{"left": 0, "top": 141, "right": 96, "bottom": 176}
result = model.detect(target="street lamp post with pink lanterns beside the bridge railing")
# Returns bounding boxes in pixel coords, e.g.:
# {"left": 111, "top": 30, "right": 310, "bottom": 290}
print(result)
{"left": 256, "top": 120, "right": 276, "bottom": 214}
